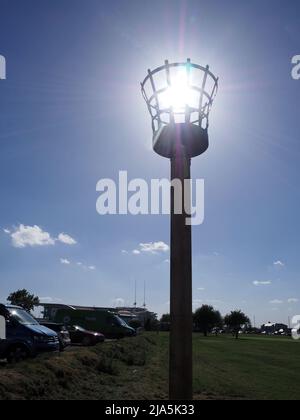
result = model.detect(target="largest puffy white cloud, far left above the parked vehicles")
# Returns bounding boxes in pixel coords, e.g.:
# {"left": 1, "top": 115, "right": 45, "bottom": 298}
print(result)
{"left": 10, "top": 225, "right": 55, "bottom": 248}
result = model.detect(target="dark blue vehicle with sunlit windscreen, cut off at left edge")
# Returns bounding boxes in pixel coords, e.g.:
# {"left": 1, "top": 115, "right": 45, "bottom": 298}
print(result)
{"left": 0, "top": 305, "right": 59, "bottom": 363}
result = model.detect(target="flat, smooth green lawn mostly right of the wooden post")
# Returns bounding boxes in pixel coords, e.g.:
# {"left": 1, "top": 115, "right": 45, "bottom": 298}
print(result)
{"left": 152, "top": 334, "right": 300, "bottom": 400}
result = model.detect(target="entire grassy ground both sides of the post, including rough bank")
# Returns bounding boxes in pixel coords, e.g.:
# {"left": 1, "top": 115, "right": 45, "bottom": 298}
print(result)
{"left": 0, "top": 333, "right": 300, "bottom": 400}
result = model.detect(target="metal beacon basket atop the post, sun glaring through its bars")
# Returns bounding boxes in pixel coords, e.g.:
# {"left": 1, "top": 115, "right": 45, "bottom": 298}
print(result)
{"left": 141, "top": 59, "right": 218, "bottom": 158}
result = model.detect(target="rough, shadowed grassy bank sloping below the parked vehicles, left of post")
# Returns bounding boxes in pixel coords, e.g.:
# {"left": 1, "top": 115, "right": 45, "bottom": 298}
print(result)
{"left": 0, "top": 335, "right": 166, "bottom": 400}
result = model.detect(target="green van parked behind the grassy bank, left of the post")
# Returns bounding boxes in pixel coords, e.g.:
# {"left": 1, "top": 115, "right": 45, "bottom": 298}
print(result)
{"left": 45, "top": 305, "right": 136, "bottom": 338}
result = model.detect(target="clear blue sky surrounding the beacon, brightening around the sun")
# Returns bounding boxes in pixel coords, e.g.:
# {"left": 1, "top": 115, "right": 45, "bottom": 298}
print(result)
{"left": 0, "top": 0, "right": 300, "bottom": 323}
